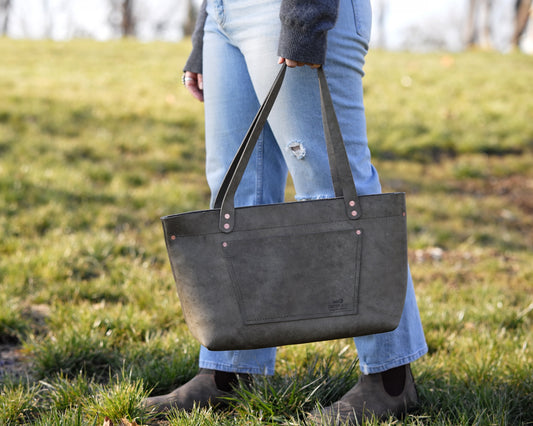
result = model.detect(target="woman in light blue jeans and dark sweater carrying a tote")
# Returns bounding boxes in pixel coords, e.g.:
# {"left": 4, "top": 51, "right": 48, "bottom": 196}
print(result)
{"left": 145, "top": 0, "right": 427, "bottom": 424}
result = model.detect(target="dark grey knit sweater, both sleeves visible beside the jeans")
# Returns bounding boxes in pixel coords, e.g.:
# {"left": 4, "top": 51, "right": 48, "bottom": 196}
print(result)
{"left": 184, "top": 0, "right": 339, "bottom": 73}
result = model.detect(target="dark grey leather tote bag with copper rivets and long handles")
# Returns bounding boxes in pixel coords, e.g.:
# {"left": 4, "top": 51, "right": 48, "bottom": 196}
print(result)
{"left": 161, "top": 66, "right": 407, "bottom": 350}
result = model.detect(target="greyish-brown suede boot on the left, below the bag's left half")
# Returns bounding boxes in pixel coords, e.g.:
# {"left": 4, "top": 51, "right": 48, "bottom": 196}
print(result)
{"left": 143, "top": 368, "right": 250, "bottom": 413}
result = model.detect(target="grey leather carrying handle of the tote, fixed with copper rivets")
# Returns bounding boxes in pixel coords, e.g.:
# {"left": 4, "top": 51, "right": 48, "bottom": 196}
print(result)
{"left": 214, "top": 64, "right": 361, "bottom": 233}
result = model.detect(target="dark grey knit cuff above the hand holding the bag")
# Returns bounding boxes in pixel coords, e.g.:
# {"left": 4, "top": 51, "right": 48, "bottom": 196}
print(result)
{"left": 278, "top": 25, "right": 327, "bottom": 64}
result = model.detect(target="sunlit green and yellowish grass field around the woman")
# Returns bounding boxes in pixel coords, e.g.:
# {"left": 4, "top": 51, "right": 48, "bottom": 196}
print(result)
{"left": 0, "top": 38, "right": 533, "bottom": 425}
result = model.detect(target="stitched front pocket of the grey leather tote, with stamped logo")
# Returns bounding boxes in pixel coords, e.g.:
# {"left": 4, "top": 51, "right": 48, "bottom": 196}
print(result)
{"left": 222, "top": 228, "right": 362, "bottom": 324}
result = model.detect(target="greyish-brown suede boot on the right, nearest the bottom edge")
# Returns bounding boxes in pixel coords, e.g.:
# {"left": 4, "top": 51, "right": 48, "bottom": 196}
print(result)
{"left": 309, "top": 365, "right": 418, "bottom": 425}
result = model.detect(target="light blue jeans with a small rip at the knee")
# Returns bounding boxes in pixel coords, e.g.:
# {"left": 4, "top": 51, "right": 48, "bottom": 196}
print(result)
{"left": 200, "top": 0, "right": 427, "bottom": 374}
